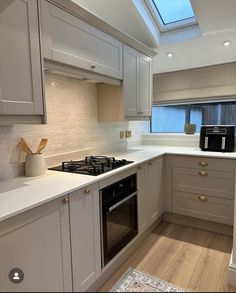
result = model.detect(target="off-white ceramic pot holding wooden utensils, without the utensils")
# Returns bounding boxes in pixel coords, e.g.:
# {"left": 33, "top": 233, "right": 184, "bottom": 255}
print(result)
{"left": 25, "top": 154, "right": 46, "bottom": 177}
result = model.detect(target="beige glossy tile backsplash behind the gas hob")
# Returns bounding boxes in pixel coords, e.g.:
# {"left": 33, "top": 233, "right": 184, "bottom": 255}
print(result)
{"left": 0, "top": 73, "right": 149, "bottom": 180}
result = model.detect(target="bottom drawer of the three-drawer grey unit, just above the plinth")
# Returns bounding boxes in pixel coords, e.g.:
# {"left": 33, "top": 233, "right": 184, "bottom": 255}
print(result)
{"left": 173, "top": 191, "right": 234, "bottom": 225}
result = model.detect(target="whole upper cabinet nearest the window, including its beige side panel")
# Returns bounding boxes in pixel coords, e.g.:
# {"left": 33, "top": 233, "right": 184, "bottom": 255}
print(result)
{"left": 97, "top": 45, "right": 152, "bottom": 122}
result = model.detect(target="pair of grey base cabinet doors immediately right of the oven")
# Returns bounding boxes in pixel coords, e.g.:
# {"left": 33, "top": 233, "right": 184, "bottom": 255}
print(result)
{"left": 137, "top": 158, "right": 163, "bottom": 233}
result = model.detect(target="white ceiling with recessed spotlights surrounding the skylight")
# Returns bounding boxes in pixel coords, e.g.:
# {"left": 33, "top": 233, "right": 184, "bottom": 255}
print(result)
{"left": 73, "top": 0, "right": 236, "bottom": 73}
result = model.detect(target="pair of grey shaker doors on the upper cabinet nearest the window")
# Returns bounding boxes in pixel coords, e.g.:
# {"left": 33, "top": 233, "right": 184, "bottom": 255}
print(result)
{"left": 123, "top": 45, "right": 152, "bottom": 116}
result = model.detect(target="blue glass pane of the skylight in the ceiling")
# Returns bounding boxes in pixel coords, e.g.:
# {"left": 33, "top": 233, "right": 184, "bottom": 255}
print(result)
{"left": 152, "top": 0, "right": 194, "bottom": 25}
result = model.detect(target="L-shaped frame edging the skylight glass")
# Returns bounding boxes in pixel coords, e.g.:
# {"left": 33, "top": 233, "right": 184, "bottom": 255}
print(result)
{"left": 144, "top": 0, "right": 197, "bottom": 32}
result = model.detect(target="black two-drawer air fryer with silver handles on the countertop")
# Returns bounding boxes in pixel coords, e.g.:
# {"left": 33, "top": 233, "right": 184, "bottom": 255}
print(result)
{"left": 200, "top": 125, "right": 235, "bottom": 152}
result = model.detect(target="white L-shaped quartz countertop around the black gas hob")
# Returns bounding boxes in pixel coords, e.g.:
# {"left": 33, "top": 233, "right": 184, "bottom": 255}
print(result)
{"left": 0, "top": 145, "right": 236, "bottom": 221}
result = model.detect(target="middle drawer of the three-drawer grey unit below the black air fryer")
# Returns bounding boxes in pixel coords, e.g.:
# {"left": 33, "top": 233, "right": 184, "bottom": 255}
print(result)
{"left": 172, "top": 167, "right": 235, "bottom": 199}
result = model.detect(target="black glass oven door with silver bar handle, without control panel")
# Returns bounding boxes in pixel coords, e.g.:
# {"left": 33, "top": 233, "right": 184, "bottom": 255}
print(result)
{"left": 101, "top": 191, "right": 138, "bottom": 267}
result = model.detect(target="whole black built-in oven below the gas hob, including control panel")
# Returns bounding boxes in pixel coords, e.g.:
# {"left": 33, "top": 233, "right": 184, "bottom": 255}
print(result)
{"left": 100, "top": 174, "right": 138, "bottom": 267}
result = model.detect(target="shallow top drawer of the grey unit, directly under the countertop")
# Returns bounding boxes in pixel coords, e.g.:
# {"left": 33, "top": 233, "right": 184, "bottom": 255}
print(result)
{"left": 172, "top": 156, "right": 235, "bottom": 172}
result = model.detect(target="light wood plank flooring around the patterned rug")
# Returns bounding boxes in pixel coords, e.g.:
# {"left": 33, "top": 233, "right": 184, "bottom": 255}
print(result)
{"left": 100, "top": 222, "right": 236, "bottom": 292}
